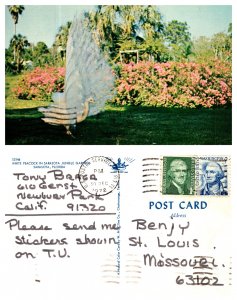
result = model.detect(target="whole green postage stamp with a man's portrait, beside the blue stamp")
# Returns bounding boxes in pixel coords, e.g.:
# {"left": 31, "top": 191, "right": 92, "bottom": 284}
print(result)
{"left": 162, "top": 157, "right": 194, "bottom": 195}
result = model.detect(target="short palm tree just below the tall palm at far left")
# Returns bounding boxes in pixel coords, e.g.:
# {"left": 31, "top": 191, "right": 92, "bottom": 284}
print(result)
{"left": 10, "top": 34, "right": 30, "bottom": 72}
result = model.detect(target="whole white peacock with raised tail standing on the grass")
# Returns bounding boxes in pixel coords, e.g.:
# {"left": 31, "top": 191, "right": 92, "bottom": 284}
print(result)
{"left": 39, "top": 18, "right": 114, "bottom": 135}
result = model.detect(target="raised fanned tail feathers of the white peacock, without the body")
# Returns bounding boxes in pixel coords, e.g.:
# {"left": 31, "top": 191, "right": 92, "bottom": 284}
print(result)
{"left": 65, "top": 18, "right": 114, "bottom": 116}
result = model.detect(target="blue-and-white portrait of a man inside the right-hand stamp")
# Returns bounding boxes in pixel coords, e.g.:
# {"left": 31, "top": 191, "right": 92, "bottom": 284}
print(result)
{"left": 197, "top": 160, "right": 228, "bottom": 196}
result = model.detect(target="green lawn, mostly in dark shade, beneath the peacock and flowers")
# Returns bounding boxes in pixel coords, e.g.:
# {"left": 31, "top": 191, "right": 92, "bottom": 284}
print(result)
{"left": 6, "top": 76, "right": 232, "bottom": 145}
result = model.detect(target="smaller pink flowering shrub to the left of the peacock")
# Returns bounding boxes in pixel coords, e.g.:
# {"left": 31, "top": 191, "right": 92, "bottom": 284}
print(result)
{"left": 14, "top": 67, "right": 65, "bottom": 100}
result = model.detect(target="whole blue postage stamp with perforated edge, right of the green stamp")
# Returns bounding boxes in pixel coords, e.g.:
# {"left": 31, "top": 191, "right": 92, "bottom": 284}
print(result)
{"left": 195, "top": 156, "right": 229, "bottom": 196}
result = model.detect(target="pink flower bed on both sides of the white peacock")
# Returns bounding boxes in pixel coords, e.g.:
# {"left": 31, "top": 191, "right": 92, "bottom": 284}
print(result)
{"left": 14, "top": 61, "right": 232, "bottom": 108}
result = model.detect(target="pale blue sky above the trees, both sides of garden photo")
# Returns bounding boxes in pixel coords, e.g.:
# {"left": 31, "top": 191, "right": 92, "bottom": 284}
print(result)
{"left": 5, "top": 5, "right": 232, "bottom": 48}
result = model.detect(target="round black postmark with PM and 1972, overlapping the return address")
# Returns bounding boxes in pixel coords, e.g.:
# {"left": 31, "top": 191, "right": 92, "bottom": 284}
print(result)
{"left": 79, "top": 156, "right": 119, "bottom": 196}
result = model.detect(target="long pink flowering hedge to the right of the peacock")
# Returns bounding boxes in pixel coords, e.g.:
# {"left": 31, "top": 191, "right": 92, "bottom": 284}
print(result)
{"left": 113, "top": 61, "right": 232, "bottom": 108}
